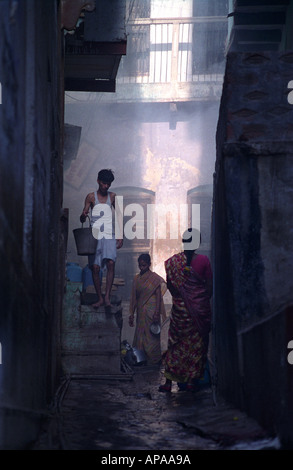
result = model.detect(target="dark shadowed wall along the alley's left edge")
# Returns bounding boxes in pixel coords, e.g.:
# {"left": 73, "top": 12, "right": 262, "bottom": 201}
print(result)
{"left": 0, "top": 0, "right": 64, "bottom": 449}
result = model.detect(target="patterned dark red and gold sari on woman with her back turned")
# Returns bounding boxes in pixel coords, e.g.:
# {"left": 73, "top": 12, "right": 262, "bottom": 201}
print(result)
{"left": 163, "top": 252, "right": 211, "bottom": 383}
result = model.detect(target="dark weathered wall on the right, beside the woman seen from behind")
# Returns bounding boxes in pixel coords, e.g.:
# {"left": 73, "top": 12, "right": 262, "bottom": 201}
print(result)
{"left": 213, "top": 52, "right": 293, "bottom": 444}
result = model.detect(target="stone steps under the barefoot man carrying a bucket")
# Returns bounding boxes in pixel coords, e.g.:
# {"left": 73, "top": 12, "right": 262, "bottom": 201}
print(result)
{"left": 61, "top": 282, "right": 128, "bottom": 378}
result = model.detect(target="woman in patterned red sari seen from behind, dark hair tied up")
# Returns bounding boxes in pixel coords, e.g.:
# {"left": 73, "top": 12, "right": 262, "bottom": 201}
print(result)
{"left": 159, "top": 229, "right": 212, "bottom": 392}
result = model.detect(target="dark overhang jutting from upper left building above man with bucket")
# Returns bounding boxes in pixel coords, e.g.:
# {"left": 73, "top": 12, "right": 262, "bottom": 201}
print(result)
{"left": 64, "top": 0, "right": 127, "bottom": 92}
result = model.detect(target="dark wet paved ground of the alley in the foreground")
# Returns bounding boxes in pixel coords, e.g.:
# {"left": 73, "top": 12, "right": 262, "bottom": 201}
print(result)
{"left": 34, "top": 366, "right": 278, "bottom": 452}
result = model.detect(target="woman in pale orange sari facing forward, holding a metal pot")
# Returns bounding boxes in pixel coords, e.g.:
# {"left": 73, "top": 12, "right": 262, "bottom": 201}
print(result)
{"left": 129, "top": 253, "right": 167, "bottom": 364}
